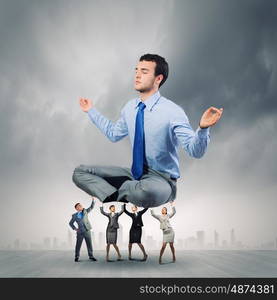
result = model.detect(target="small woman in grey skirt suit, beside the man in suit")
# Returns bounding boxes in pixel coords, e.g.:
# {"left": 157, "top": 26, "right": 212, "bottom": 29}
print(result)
{"left": 100, "top": 205, "right": 124, "bottom": 262}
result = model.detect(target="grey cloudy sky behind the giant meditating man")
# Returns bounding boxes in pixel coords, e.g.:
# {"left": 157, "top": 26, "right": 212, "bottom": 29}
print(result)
{"left": 0, "top": 0, "right": 277, "bottom": 244}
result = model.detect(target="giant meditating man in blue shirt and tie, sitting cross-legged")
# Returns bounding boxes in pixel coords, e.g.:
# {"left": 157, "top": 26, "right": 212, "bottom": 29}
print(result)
{"left": 72, "top": 54, "right": 223, "bottom": 208}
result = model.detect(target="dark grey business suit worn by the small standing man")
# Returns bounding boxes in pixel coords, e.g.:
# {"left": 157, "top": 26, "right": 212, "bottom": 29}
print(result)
{"left": 69, "top": 201, "right": 95, "bottom": 258}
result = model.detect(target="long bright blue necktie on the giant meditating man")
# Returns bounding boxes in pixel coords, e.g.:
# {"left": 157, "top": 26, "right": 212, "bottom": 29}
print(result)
{"left": 132, "top": 102, "right": 146, "bottom": 180}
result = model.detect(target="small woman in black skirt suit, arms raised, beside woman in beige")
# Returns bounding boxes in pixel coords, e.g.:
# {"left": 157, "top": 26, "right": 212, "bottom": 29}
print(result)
{"left": 124, "top": 204, "right": 148, "bottom": 261}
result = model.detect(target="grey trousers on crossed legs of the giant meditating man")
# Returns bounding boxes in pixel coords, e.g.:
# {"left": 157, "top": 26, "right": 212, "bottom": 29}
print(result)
{"left": 72, "top": 165, "right": 177, "bottom": 207}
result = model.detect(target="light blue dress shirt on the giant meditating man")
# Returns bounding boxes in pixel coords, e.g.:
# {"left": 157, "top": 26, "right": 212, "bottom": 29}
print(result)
{"left": 88, "top": 91, "right": 210, "bottom": 178}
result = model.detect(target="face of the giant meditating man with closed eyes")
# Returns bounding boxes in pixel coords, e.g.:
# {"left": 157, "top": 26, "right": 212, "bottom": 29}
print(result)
{"left": 134, "top": 60, "right": 163, "bottom": 93}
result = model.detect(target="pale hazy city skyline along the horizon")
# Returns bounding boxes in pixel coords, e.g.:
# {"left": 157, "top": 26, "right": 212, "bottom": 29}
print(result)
{"left": 0, "top": 224, "right": 277, "bottom": 251}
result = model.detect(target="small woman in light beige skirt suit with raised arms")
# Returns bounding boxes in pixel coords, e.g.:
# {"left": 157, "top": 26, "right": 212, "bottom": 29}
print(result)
{"left": 151, "top": 202, "right": 176, "bottom": 264}
